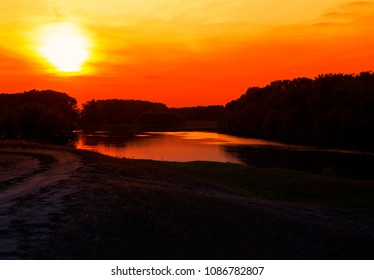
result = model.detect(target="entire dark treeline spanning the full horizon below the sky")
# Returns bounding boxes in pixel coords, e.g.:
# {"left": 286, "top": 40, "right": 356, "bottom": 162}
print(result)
{"left": 0, "top": 72, "right": 374, "bottom": 150}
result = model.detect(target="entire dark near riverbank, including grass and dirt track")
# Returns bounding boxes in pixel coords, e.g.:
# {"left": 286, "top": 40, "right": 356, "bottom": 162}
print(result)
{"left": 0, "top": 142, "right": 374, "bottom": 259}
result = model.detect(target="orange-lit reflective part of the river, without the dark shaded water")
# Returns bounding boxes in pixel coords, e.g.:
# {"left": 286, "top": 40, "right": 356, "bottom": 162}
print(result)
{"left": 77, "top": 131, "right": 282, "bottom": 163}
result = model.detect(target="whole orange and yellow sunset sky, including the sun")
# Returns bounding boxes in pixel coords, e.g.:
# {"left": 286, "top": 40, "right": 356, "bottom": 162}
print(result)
{"left": 0, "top": 0, "right": 374, "bottom": 107}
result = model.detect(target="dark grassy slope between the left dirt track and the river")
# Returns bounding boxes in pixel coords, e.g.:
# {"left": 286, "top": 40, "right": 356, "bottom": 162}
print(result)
{"left": 42, "top": 149, "right": 374, "bottom": 259}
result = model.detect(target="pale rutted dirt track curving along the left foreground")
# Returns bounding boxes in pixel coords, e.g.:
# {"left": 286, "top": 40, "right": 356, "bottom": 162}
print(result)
{"left": 0, "top": 148, "right": 82, "bottom": 259}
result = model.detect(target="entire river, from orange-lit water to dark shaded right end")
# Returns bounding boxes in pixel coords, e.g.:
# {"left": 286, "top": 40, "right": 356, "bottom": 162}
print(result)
{"left": 76, "top": 131, "right": 374, "bottom": 180}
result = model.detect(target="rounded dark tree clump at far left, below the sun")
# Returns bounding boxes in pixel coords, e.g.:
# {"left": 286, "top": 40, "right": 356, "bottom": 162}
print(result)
{"left": 0, "top": 90, "right": 79, "bottom": 144}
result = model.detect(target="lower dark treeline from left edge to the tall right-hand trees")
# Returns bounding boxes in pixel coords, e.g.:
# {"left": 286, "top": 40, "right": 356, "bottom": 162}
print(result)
{"left": 0, "top": 90, "right": 224, "bottom": 144}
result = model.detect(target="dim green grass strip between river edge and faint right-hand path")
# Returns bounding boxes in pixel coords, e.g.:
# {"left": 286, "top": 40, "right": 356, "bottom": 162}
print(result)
{"left": 145, "top": 161, "right": 374, "bottom": 209}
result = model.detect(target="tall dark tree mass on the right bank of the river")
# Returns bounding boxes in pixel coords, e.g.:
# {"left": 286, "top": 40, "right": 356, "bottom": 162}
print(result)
{"left": 219, "top": 72, "right": 374, "bottom": 150}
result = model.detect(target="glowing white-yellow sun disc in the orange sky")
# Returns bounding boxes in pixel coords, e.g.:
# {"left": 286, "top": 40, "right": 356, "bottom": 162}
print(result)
{"left": 38, "top": 23, "right": 90, "bottom": 73}
